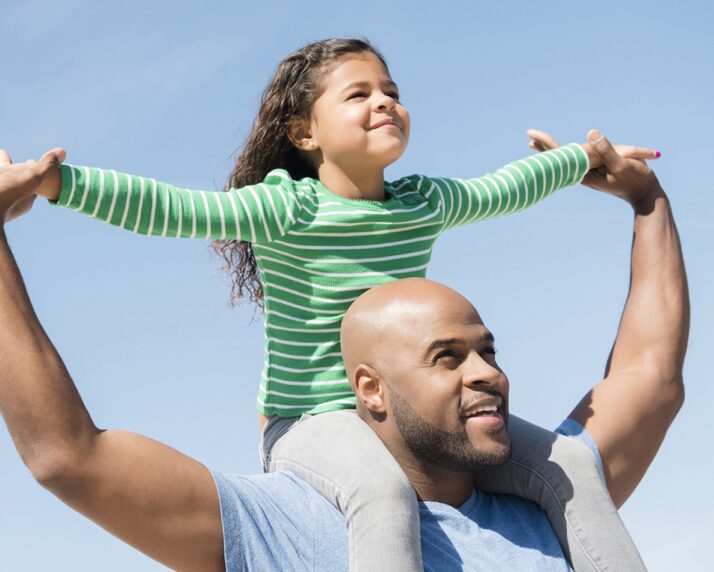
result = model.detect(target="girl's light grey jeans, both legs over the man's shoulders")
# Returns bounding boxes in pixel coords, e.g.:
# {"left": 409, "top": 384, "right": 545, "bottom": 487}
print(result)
{"left": 262, "top": 410, "right": 646, "bottom": 572}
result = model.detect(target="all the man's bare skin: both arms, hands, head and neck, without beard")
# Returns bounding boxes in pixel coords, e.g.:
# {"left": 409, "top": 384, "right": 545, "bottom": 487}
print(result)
{"left": 0, "top": 134, "right": 689, "bottom": 570}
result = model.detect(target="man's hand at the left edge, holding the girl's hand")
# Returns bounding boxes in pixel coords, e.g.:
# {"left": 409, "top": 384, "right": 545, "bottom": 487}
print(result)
{"left": 0, "top": 147, "right": 66, "bottom": 223}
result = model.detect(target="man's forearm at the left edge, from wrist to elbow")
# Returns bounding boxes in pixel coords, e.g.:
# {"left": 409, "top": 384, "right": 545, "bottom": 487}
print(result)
{"left": 0, "top": 227, "right": 98, "bottom": 486}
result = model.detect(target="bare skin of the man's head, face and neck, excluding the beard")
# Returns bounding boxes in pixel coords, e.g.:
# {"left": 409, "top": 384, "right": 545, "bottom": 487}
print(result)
{"left": 342, "top": 278, "right": 510, "bottom": 506}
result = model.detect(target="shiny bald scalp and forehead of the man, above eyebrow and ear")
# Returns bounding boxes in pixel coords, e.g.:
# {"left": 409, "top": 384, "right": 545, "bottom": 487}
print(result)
{"left": 341, "top": 278, "right": 481, "bottom": 380}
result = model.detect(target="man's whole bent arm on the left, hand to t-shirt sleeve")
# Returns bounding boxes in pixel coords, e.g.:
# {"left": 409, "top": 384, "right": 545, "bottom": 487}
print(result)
{"left": 0, "top": 152, "right": 224, "bottom": 570}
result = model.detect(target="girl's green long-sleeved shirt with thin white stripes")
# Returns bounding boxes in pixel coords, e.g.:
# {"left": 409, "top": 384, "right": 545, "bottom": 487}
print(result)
{"left": 57, "top": 144, "right": 589, "bottom": 416}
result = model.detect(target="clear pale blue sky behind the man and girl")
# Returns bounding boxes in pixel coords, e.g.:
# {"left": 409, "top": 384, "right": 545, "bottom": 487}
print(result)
{"left": 0, "top": 0, "right": 714, "bottom": 571}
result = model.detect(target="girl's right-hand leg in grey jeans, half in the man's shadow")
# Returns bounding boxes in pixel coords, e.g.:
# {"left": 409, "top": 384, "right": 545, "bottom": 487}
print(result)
{"left": 474, "top": 415, "right": 646, "bottom": 572}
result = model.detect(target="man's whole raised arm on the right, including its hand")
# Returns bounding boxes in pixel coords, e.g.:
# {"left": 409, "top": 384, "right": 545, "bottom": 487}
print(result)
{"left": 570, "top": 135, "right": 689, "bottom": 507}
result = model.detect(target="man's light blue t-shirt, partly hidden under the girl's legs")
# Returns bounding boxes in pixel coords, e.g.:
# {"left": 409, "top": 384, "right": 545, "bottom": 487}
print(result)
{"left": 213, "top": 420, "right": 600, "bottom": 572}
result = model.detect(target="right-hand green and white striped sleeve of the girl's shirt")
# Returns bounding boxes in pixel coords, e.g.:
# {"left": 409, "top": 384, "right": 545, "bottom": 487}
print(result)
{"left": 425, "top": 143, "right": 590, "bottom": 230}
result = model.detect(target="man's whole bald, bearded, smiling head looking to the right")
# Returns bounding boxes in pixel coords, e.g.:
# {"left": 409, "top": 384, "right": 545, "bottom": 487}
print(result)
{"left": 342, "top": 278, "right": 510, "bottom": 471}
